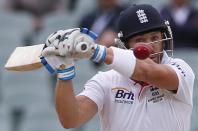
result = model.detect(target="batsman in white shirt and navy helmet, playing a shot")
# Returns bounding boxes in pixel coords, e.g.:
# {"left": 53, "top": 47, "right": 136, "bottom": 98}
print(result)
{"left": 41, "top": 4, "right": 195, "bottom": 131}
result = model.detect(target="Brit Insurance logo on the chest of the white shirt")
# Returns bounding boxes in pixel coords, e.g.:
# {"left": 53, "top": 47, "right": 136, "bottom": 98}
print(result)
{"left": 112, "top": 87, "right": 134, "bottom": 104}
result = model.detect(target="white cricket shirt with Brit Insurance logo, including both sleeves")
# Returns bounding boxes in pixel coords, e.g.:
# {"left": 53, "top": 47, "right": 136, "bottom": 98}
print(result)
{"left": 79, "top": 54, "right": 195, "bottom": 131}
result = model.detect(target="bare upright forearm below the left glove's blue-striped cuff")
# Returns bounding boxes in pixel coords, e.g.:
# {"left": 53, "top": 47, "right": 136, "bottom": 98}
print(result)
{"left": 55, "top": 80, "right": 78, "bottom": 128}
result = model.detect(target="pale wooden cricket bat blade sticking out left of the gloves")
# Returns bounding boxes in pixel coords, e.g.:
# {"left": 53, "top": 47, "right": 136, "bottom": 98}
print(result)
{"left": 5, "top": 44, "right": 44, "bottom": 71}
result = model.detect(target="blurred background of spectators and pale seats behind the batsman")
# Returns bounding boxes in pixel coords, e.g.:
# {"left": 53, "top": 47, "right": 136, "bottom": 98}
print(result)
{"left": 0, "top": 0, "right": 198, "bottom": 131}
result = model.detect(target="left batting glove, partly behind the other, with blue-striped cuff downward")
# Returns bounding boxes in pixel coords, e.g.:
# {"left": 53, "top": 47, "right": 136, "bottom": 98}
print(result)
{"left": 40, "top": 29, "right": 78, "bottom": 80}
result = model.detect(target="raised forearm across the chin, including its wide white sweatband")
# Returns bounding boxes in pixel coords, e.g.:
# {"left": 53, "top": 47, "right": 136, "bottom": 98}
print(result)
{"left": 105, "top": 48, "right": 178, "bottom": 90}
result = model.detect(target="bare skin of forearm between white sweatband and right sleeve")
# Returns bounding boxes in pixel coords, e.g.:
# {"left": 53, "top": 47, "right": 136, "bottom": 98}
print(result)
{"left": 132, "top": 59, "right": 179, "bottom": 90}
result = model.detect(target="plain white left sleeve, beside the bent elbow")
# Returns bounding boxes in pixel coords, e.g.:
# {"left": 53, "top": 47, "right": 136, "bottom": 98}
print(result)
{"left": 78, "top": 73, "right": 106, "bottom": 112}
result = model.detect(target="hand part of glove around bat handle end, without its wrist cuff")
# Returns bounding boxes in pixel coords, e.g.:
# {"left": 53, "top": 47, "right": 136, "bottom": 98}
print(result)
{"left": 55, "top": 28, "right": 97, "bottom": 59}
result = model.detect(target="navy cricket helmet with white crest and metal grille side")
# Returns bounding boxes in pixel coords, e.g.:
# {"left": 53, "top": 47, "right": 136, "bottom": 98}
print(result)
{"left": 118, "top": 4, "right": 173, "bottom": 56}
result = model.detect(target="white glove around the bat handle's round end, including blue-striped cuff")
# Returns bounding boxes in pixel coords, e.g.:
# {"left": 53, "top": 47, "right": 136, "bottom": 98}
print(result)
{"left": 58, "top": 28, "right": 106, "bottom": 63}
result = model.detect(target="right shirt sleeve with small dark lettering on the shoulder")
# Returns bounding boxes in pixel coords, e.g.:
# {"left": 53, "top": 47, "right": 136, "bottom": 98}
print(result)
{"left": 168, "top": 59, "right": 195, "bottom": 105}
